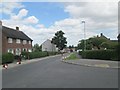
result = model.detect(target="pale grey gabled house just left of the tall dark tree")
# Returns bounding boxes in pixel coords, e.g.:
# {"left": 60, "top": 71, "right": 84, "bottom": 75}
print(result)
{"left": 42, "top": 39, "right": 58, "bottom": 52}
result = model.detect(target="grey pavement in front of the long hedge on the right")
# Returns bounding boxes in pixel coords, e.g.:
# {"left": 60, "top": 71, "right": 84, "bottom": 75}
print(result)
{"left": 62, "top": 54, "right": 120, "bottom": 69}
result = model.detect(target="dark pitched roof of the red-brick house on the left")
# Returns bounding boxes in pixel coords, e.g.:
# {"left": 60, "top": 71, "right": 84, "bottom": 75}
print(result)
{"left": 2, "top": 26, "right": 33, "bottom": 41}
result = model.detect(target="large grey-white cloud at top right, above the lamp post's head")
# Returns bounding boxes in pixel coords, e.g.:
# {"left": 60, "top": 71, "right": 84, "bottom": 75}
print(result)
{"left": 65, "top": 2, "right": 118, "bottom": 21}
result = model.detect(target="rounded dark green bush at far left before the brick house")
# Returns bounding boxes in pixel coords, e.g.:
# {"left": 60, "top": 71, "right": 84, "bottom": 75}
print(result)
{"left": 2, "top": 53, "right": 14, "bottom": 64}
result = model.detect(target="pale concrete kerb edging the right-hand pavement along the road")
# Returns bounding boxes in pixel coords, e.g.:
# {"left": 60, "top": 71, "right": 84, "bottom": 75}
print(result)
{"left": 62, "top": 60, "right": 120, "bottom": 69}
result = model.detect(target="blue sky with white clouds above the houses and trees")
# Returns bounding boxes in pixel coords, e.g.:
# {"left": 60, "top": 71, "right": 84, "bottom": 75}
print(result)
{"left": 0, "top": 2, "right": 118, "bottom": 45}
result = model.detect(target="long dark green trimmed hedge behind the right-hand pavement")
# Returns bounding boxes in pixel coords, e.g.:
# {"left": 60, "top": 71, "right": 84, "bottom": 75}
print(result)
{"left": 81, "top": 50, "right": 118, "bottom": 61}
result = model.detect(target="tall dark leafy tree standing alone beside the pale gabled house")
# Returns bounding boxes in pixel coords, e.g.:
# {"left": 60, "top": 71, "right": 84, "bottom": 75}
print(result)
{"left": 51, "top": 30, "right": 67, "bottom": 51}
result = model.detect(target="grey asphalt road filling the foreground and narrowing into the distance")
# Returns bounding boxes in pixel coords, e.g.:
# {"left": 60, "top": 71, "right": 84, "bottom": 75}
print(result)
{"left": 2, "top": 56, "right": 118, "bottom": 88}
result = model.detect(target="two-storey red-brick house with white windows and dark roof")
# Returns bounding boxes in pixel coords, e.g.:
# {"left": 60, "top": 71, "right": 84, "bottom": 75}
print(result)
{"left": 2, "top": 22, "right": 33, "bottom": 55}
